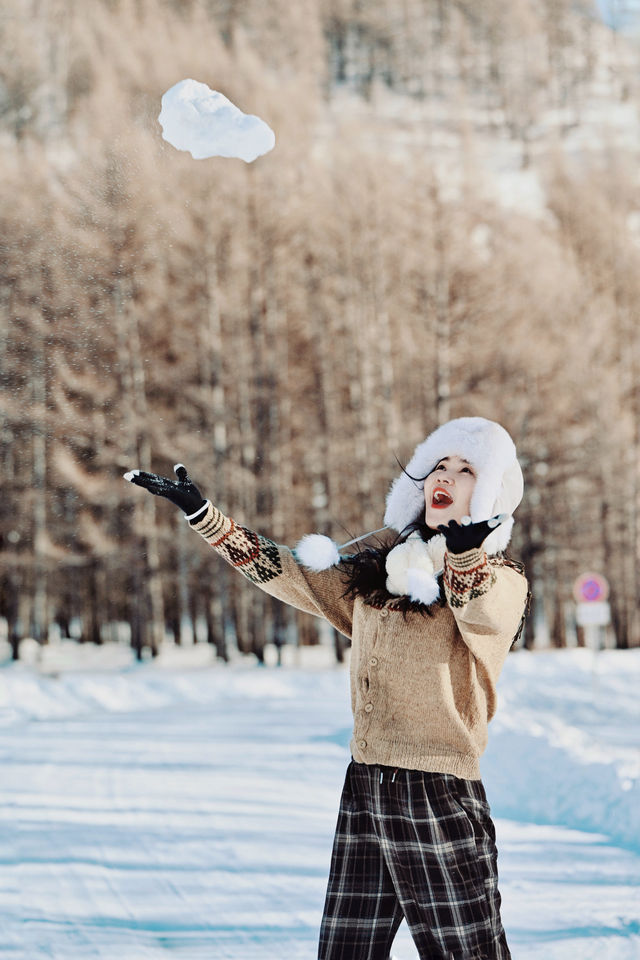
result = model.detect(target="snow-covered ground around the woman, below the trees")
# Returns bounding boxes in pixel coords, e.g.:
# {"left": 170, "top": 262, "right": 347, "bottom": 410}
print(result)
{"left": 0, "top": 643, "right": 640, "bottom": 960}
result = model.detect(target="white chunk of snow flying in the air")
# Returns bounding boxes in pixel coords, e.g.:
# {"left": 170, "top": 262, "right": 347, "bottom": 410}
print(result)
{"left": 158, "top": 80, "right": 276, "bottom": 163}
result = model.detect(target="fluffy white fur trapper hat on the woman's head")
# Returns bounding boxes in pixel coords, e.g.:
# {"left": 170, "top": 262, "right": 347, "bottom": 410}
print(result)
{"left": 384, "top": 417, "right": 524, "bottom": 554}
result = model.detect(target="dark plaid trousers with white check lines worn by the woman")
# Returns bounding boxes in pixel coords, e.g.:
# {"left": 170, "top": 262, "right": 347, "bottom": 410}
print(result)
{"left": 318, "top": 761, "right": 511, "bottom": 960}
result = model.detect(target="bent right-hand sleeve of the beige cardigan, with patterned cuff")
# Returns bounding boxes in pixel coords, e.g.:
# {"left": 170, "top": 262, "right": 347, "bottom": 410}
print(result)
{"left": 443, "top": 548, "right": 527, "bottom": 679}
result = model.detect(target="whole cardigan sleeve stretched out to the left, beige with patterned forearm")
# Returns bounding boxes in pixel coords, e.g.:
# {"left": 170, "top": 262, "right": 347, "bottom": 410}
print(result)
{"left": 185, "top": 503, "right": 353, "bottom": 637}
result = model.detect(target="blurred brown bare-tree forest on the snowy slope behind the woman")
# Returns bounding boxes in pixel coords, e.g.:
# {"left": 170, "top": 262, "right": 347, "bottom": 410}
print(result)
{"left": 0, "top": 0, "right": 640, "bottom": 659}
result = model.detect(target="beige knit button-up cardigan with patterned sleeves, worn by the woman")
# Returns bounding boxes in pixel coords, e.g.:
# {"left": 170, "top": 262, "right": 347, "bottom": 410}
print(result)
{"left": 193, "top": 504, "right": 527, "bottom": 780}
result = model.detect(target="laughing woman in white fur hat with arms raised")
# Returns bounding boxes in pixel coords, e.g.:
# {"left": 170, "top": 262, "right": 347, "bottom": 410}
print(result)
{"left": 125, "top": 417, "right": 527, "bottom": 960}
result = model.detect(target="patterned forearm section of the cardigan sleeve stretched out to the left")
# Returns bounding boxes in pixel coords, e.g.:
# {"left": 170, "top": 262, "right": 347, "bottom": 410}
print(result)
{"left": 194, "top": 504, "right": 282, "bottom": 584}
